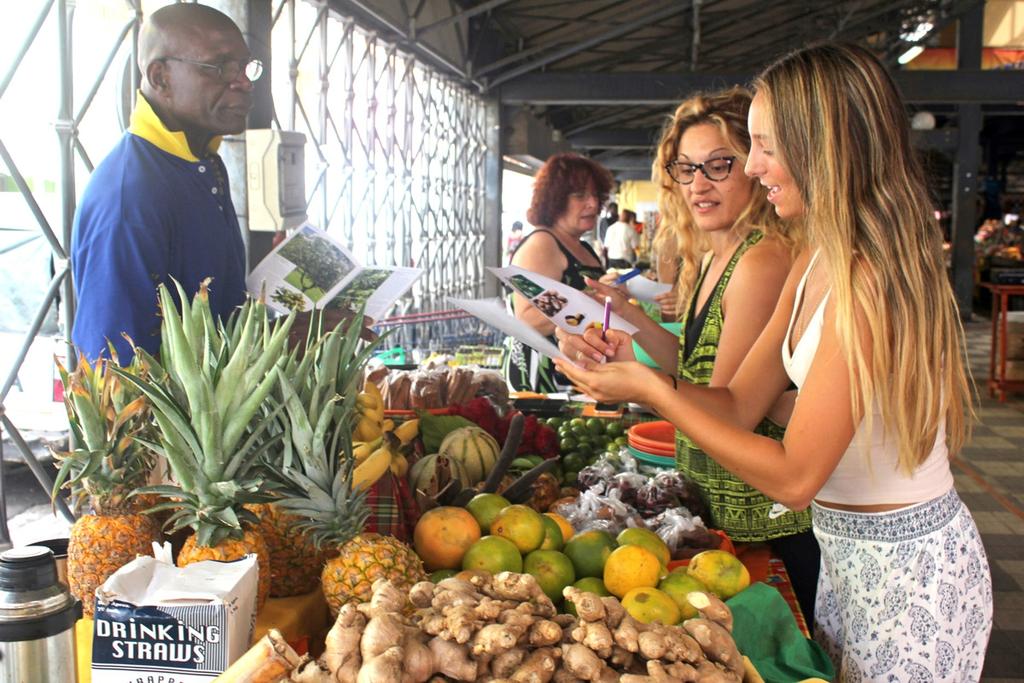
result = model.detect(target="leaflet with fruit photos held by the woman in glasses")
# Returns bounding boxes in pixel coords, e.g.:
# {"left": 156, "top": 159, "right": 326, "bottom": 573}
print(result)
{"left": 487, "top": 265, "right": 637, "bottom": 335}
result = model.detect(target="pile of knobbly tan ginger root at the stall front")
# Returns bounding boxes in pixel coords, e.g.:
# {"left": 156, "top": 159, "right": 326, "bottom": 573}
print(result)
{"left": 222, "top": 572, "right": 743, "bottom": 683}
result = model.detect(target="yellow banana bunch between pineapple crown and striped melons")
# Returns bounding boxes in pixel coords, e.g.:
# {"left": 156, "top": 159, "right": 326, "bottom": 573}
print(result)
{"left": 352, "top": 382, "right": 420, "bottom": 490}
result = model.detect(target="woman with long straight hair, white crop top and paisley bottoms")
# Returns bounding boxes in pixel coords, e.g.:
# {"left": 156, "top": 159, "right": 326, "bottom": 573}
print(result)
{"left": 560, "top": 44, "right": 992, "bottom": 681}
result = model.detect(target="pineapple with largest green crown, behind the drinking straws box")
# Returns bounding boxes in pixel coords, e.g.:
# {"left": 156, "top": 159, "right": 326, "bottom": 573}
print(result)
{"left": 122, "top": 283, "right": 294, "bottom": 606}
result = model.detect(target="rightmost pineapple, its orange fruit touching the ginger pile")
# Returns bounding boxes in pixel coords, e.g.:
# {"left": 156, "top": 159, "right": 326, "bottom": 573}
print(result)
{"left": 271, "top": 315, "right": 425, "bottom": 614}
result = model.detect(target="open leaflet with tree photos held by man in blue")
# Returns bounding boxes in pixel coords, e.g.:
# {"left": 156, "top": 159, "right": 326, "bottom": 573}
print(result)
{"left": 246, "top": 223, "right": 423, "bottom": 321}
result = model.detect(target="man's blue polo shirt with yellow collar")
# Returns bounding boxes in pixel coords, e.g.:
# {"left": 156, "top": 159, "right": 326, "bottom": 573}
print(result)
{"left": 72, "top": 93, "right": 246, "bottom": 362}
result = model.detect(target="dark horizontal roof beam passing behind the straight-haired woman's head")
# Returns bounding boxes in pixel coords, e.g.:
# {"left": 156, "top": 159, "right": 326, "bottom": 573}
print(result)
{"left": 501, "top": 70, "right": 1024, "bottom": 106}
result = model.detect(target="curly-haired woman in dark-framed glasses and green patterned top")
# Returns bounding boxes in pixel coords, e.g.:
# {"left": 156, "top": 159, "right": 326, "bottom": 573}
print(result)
{"left": 577, "top": 88, "right": 819, "bottom": 623}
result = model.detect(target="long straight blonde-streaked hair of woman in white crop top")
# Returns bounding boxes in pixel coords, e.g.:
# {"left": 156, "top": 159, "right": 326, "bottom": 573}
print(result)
{"left": 755, "top": 43, "right": 972, "bottom": 473}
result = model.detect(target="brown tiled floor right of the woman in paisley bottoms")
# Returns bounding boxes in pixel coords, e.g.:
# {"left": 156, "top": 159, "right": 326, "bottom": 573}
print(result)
{"left": 953, "top": 319, "right": 1024, "bottom": 683}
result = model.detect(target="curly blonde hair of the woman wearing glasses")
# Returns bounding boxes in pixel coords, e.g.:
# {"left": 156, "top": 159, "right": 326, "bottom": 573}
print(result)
{"left": 651, "top": 87, "right": 797, "bottom": 313}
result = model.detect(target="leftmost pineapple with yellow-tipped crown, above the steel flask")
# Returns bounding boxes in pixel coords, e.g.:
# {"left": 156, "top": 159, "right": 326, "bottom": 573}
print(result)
{"left": 52, "top": 347, "right": 160, "bottom": 617}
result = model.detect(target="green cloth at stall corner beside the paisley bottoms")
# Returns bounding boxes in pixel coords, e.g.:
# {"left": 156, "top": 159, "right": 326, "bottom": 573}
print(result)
{"left": 726, "top": 584, "right": 836, "bottom": 683}
